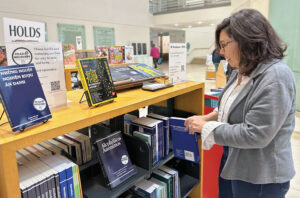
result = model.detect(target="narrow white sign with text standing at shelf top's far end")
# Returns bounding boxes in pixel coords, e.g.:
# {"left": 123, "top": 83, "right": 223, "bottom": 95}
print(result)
{"left": 169, "top": 43, "right": 186, "bottom": 83}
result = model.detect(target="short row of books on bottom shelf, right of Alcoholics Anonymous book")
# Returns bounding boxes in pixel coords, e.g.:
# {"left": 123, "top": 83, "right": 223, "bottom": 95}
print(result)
{"left": 130, "top": 165, "right": 181, "bottom": 198}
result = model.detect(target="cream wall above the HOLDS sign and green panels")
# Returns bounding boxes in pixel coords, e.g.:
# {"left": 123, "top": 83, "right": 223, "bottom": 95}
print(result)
{"left": 0, "top": 0, "right": 152, "bottom": 51}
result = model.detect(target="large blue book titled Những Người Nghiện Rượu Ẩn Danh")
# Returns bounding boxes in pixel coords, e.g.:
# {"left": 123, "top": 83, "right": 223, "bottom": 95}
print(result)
{"left": 0, "top": 64, "right": 52, "bottom": 131}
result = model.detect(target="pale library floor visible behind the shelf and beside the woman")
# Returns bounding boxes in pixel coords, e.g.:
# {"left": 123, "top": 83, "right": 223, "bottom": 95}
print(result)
{"left": 158, "top": 63, "right": 300, "bottom": 198}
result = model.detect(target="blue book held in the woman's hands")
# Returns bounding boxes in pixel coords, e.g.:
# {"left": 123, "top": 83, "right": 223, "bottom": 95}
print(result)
{"left": 169, "top": 117, "right": 200, "bottom": 163}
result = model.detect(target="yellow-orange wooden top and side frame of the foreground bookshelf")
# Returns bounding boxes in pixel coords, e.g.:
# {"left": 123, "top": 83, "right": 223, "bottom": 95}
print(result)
{"left": 0, "top": 81, "right": 204, "bottom": 198}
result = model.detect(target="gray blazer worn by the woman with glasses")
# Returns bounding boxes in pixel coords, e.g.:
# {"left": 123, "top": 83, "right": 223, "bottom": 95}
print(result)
{"left": 214, "top": 60, "right": 296, "bottom": 184}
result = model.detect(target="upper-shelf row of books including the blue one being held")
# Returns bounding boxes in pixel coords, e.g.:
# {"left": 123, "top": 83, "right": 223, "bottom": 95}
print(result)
{"left": 124, "top": 113, "right": 200, "bottom": 166}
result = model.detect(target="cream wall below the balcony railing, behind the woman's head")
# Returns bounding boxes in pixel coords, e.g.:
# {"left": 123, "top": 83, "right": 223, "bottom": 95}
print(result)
{"left": 153, "top": 0, "right": 269, "bottom": 62}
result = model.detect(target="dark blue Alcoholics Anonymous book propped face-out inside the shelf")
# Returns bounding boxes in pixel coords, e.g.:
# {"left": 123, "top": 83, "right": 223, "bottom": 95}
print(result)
{"left": 95, "top": 131, "right": 136, "bottom": 188}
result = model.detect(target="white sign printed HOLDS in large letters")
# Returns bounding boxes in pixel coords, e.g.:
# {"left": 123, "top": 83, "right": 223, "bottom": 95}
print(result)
{"left": 3, "top": 17, "right": 45, "bottom": 43}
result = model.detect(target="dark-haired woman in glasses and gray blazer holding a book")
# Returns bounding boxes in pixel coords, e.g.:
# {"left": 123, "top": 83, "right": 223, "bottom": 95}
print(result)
{"left": 185, "top": 9, "right": 296, "bottom": 198}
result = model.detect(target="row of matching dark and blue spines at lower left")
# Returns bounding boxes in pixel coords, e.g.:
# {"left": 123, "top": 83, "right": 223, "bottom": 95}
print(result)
{"left": 16, "top": 148, "right": 83, "bottom": 198}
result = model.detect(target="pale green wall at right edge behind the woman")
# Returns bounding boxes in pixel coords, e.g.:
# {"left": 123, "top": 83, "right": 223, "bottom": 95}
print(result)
{"left": 269, "top": 0, "right": 300, "bottom": 111}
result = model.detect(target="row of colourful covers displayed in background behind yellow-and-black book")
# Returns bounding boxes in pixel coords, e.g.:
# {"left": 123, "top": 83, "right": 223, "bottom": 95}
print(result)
{"left": 62, "top": 44, "right": 134, "bottom": 66}
